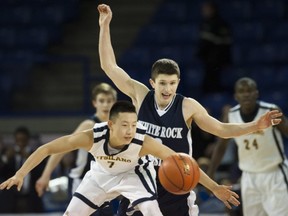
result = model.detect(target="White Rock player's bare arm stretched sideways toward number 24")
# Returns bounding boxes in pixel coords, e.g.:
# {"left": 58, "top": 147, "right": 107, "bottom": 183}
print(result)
{"left": 183, "top": 98, "right": 283, "bottom": 138}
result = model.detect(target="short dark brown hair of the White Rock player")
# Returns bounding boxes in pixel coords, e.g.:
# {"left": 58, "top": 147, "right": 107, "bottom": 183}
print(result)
{"left": 151, "top": 58, "right": 180, "bottom": 81}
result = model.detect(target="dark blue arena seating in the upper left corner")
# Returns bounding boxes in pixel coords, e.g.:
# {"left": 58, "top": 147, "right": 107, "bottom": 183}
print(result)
{"left": 0, "top": 0, "right": 79, "bottom": 111}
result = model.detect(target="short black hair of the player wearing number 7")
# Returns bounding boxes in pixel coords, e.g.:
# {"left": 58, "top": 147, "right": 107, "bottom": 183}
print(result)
{"left": 109, "top": 101, "right": 137, "bottom": 120}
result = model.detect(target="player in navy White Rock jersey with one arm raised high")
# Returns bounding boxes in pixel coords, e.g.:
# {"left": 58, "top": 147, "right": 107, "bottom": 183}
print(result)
{"left": 98, "top": 4, "right": 281, "bottom": 216}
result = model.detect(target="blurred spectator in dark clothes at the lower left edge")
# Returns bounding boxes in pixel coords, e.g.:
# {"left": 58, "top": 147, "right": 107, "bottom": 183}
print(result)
{"left": 0, "top": 126, "right": 43, "bottom": 213}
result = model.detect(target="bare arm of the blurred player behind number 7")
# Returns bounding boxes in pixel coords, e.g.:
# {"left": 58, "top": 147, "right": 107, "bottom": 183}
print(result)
{"left": 35, "top": 120, "right": 95, "bottom": 197}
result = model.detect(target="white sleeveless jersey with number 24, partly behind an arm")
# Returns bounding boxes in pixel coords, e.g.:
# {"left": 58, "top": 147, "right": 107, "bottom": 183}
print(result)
{"left": 228, "top": 101, "right": 286, "bottom": 172}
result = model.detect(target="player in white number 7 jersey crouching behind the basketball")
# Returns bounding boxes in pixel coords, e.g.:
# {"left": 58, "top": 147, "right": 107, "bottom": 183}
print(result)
{"left": 0, "top": 101, "right": 239, "bottom": 216}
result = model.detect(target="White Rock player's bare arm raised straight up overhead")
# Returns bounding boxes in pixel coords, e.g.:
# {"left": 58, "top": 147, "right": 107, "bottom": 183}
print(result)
{"left": 98, "top": 4, "right": 149, "bottom": 109}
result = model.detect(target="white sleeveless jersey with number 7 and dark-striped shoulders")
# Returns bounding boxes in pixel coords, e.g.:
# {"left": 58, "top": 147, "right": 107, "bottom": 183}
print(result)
{"left": 89, "top": 122, "right": 146, "bottom": 175}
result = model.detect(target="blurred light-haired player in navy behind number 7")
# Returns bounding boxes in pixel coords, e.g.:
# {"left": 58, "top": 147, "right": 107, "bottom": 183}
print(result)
{"left": 35, "top": 83, "right": 117, "bottom": 216}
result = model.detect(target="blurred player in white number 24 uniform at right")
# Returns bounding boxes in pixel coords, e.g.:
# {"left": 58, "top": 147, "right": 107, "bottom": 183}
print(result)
{"left": 208, "top": 77, "right": 288, "bottom": 216}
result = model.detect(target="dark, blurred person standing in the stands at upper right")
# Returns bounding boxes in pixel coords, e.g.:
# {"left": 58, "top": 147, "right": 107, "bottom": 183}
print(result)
{"left": 197, "top": 1, "right": 232, "bottom": 93}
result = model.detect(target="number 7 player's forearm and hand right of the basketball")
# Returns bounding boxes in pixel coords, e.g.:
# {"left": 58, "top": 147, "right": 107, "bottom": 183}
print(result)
{"left": 199, "top": 169, "right": 240, "bottom": 209}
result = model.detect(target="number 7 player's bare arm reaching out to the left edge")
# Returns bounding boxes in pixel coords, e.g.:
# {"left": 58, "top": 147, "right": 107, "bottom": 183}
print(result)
{"left": 0, "top": 130, "right": 93, "bottom": 191}
